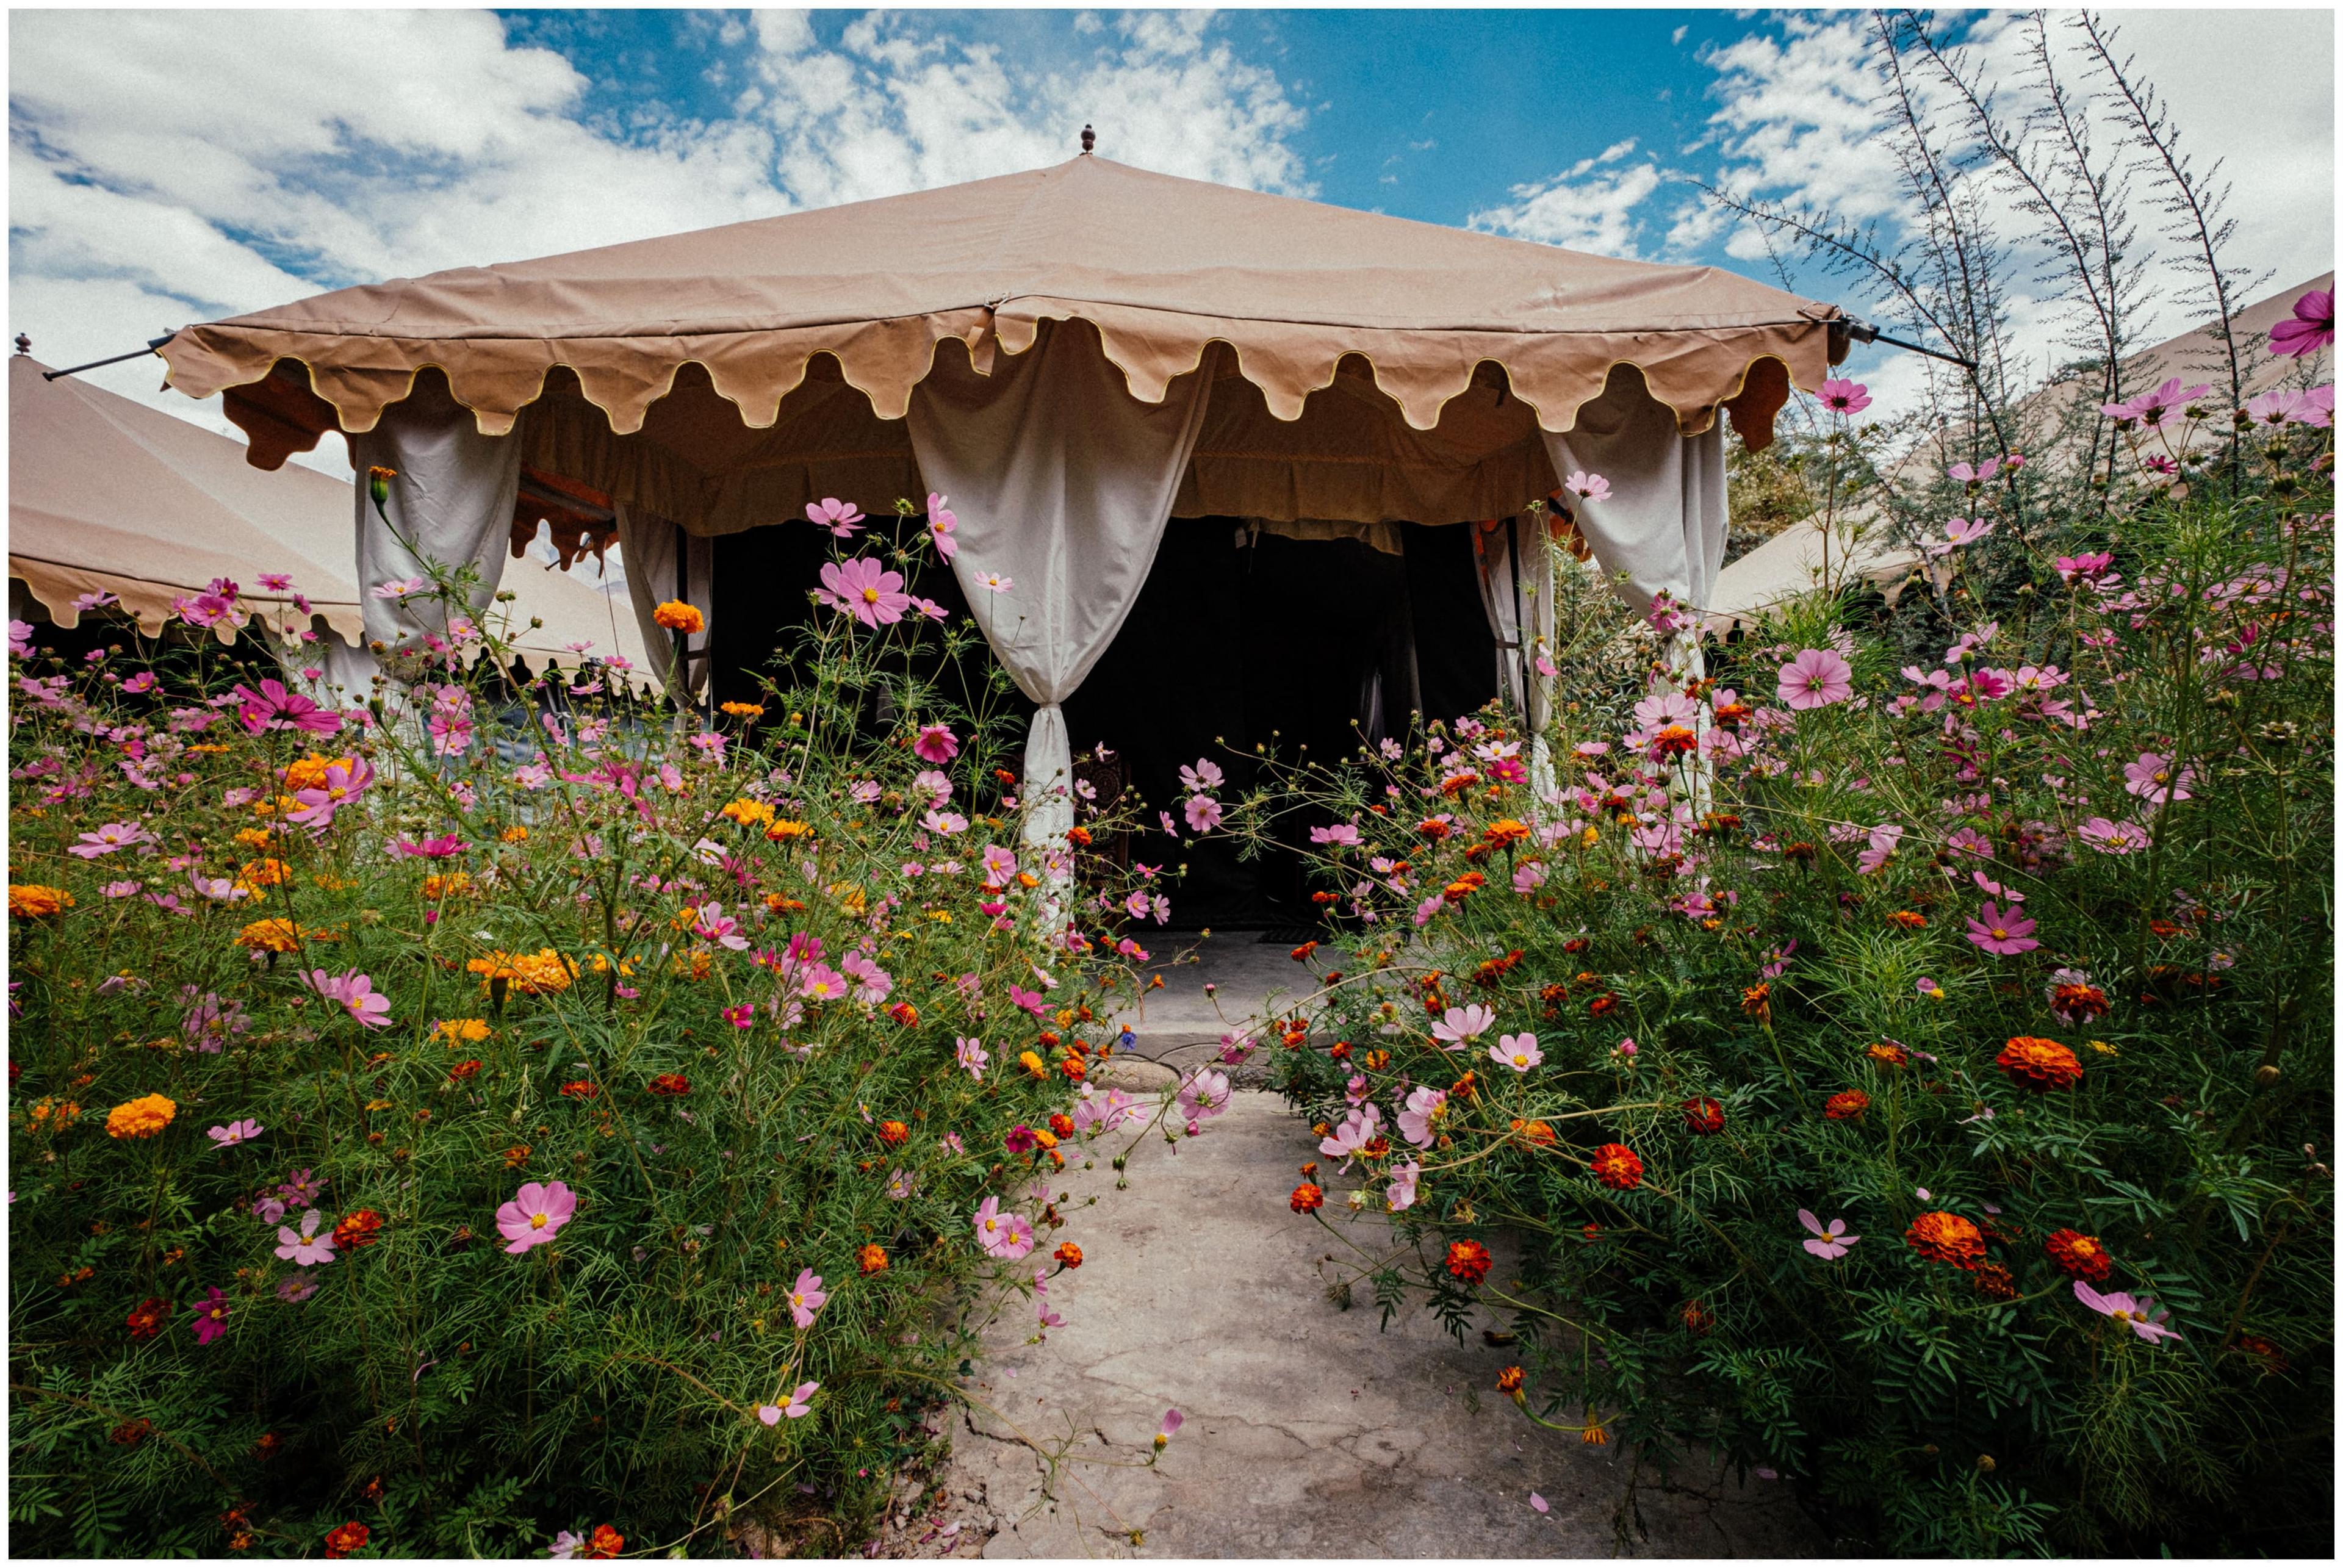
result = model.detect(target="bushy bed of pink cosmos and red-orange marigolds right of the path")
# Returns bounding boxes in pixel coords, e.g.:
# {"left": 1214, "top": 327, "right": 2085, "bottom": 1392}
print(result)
{"left": 1228, "top": 459, "right": 2334, "bottom": 1556}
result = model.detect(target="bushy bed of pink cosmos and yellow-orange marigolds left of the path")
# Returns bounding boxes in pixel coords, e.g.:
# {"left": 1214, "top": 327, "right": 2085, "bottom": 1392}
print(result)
{"left": 9, "top": 508, "right": 1136, "bottom": 1556}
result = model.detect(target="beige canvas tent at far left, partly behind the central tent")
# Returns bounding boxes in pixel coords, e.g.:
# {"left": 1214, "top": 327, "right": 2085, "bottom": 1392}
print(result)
{"left": 9, "top": 354, "right": 663, "bottom": 680}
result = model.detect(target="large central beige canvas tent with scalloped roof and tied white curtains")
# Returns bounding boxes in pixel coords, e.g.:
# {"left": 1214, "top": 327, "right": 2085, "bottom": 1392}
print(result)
{"left": 159, "top": 153, "right": 1849, "bottom": 881}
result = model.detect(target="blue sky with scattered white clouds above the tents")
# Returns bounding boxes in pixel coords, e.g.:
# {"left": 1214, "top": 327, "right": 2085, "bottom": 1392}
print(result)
{"left": 9, "top": 9, "right": 2334, "bottom": 445}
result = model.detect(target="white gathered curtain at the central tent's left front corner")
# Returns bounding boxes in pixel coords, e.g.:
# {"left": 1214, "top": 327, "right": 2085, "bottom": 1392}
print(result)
{"left": 349, "top": 389, "right": 520, "bottom": 656}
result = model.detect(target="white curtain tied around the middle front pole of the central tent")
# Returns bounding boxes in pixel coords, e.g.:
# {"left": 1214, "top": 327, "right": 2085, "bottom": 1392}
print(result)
{"left": 912, "top": 323, "right": 1211, "bottom": 846}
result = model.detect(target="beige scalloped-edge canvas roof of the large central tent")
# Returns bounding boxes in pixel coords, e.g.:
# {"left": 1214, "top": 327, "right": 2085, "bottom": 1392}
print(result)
{"left": 162, "top": 155, "right": 1844, "bottom": 464}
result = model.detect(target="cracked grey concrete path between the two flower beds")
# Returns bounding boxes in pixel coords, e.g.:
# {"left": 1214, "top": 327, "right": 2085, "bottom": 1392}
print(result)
{"left": 898, "top": 1092, "right": 1827, "bottom": 1559}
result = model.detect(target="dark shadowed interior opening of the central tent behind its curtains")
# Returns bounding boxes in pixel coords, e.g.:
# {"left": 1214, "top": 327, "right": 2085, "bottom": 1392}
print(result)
{"left": 710, "top": 518, "right": 1497, "bottom": 930}
